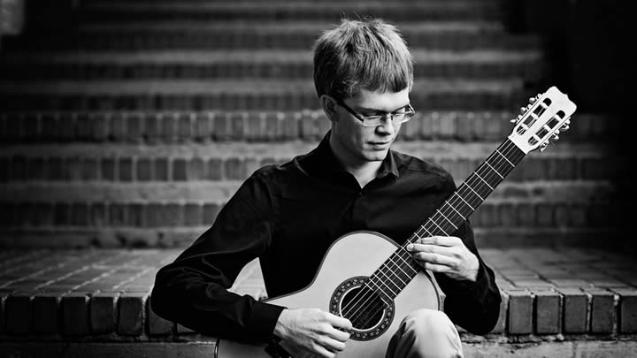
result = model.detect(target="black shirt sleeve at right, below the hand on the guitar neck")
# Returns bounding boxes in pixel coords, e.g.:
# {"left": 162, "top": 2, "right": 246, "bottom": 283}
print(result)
{"left": 435, "top": 221, "right": 501, "bottom": 334}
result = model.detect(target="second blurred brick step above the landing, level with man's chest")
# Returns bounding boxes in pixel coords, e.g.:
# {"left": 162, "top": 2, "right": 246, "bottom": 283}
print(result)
{"left": 0, "top": 180, "right": 616, "bottom": 206}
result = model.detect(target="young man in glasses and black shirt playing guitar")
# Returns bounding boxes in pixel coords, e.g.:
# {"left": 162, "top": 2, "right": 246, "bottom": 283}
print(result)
{"left": 152, "top": 20, "right": 500, "bottom": 357}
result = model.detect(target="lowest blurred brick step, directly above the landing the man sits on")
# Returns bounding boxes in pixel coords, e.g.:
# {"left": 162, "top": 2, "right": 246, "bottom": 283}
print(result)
{"left": 0, "top": 199, "right": 620, "bottom": 248}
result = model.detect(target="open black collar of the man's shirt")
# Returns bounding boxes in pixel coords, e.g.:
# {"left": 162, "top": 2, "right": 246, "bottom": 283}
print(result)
{"left": 299, "top": 131, "right": 399, "bottom": 178}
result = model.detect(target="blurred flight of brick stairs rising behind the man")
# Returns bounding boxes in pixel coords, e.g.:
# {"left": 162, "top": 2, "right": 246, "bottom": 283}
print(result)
{"left": 0, "top": 0, "right": 623, "bottom": 247}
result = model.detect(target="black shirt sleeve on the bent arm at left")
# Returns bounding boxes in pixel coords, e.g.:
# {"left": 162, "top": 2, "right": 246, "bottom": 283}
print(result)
{"left": 151, "top": 175, "right": 283, "bottom": 342}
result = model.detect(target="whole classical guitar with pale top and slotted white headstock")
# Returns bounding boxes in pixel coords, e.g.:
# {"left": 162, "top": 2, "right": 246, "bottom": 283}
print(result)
{"left": 215, "top": 87, "right": 576, "bottom": 358}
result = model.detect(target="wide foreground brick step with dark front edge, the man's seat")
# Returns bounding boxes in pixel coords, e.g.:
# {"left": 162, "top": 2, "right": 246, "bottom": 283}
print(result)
{"left": 0, "top": 247, "right": 637, "bottom": 344}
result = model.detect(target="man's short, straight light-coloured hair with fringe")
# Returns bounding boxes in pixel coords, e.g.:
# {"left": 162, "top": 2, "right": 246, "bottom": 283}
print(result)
{"left": 314, "top": 19, "right": 414, "bottom": 100}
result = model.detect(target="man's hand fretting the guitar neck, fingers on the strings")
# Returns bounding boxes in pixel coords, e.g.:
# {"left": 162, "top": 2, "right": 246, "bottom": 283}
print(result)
{"left": 407, "top": 236, "right": 480, "bottom": 282}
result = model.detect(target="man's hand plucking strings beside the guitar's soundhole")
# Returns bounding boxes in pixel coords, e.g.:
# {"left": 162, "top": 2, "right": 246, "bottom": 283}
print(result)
{"left": 274, "top": 308, "right": 352, "bottom": 358}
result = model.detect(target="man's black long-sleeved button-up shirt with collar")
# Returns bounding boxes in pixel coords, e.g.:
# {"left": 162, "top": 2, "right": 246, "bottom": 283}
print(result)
{"left": 151, "top": 133, "right": 500, "bottom": 341}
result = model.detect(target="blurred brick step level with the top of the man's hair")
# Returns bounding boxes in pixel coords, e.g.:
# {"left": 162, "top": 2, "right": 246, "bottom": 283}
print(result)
{"left": 3, "top": 21, "right": 540, "bottom": 51}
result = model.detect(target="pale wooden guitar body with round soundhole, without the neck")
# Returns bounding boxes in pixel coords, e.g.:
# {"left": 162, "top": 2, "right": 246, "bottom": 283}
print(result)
{"left": 217, "top": 231, "right": 442, "bottom": 358}
